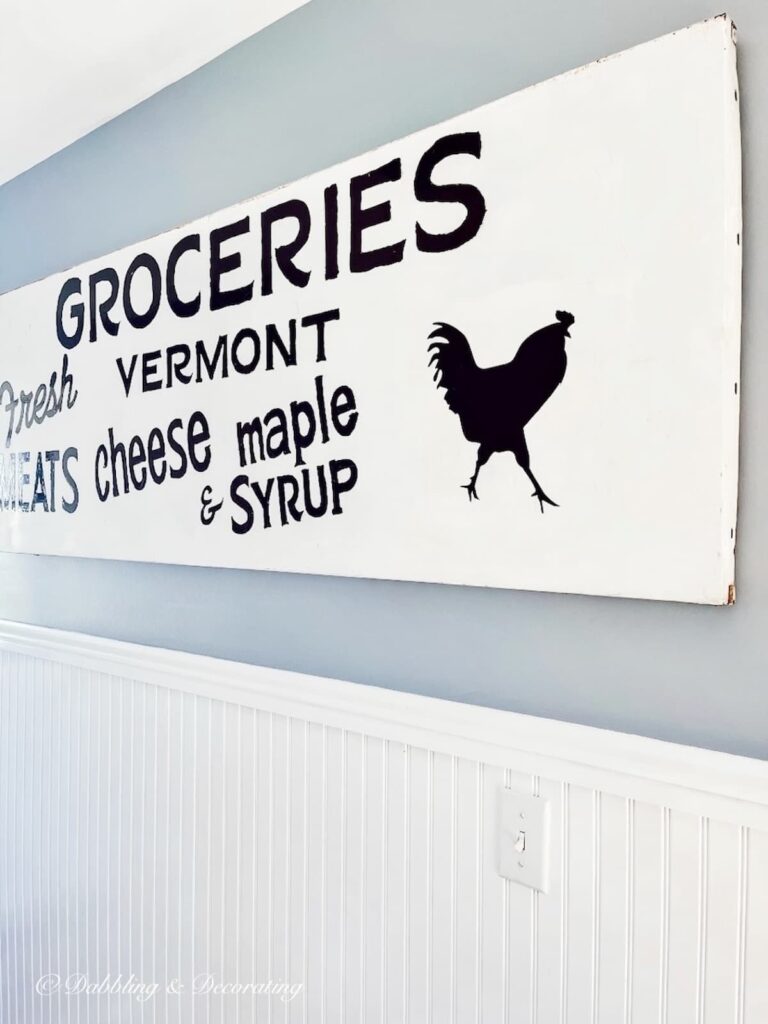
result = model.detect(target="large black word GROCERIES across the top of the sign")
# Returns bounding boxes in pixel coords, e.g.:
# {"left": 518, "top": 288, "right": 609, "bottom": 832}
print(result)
{"left": 56, "top": 131, "right": 485, "bottom": 349}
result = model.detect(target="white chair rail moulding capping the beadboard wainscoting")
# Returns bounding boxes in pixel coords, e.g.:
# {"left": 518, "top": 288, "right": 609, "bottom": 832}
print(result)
{"left": 0, "top": 621, "right": 768, "bottom": 831}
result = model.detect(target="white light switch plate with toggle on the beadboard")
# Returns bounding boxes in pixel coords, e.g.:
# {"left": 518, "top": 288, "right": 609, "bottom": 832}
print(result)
{"left": 497, "top": 788, "right": 550, "bottom": 893}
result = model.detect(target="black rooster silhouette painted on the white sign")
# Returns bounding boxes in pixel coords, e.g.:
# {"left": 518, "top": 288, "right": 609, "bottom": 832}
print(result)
{"left": 429, "top": 309, "right": 574, "bottom": 512}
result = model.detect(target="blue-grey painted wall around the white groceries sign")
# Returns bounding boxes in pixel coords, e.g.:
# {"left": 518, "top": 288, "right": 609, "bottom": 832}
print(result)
{"left": 0, "top": 0, "right": 768, "bottom": 758}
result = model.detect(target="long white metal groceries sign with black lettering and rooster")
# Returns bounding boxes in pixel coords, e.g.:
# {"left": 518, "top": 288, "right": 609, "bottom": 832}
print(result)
{"left": 0, "top": 18, "right": 741, "bottom": 603}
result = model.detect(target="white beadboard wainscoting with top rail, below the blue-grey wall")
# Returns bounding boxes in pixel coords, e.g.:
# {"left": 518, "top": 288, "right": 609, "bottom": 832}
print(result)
{"left": 0, "top": 624, "right": 768, "bottom": 1024}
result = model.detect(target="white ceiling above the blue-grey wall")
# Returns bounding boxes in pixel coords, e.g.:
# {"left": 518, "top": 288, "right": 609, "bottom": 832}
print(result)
{"left": 0, "top": 0, "right": 306, "bottom": 183}
